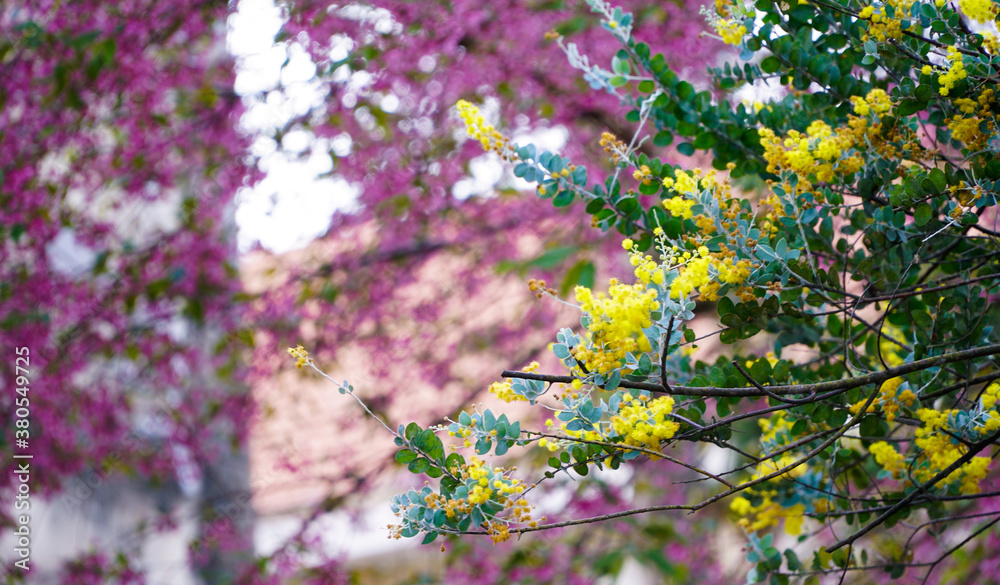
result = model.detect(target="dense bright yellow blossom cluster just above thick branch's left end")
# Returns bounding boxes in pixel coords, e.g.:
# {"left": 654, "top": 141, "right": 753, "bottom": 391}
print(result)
{"left": 574, "top": 279, "right": 660, "bottom": 374}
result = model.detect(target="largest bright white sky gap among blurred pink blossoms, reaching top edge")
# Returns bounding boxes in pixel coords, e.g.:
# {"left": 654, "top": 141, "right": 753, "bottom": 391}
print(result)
{"left": 228, "top": 0, "right": 362, "bottom": 253}
